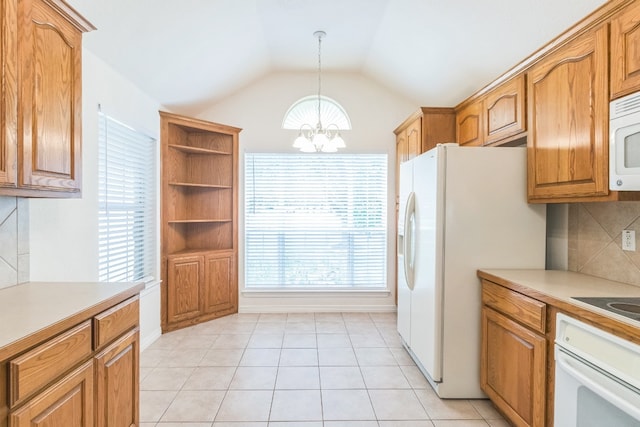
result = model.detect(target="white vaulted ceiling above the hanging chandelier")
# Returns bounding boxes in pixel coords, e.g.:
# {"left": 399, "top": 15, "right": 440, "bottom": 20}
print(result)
{"left": 68, "top": 0, "right": 606, "bottom": 112}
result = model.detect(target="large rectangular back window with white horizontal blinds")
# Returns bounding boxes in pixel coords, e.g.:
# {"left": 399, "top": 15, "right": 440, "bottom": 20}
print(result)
{"left": 245, "top": 153, "right": 387, "bottom": 289}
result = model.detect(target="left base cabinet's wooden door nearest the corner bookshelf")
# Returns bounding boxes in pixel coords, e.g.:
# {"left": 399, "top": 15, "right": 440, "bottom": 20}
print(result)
{"left": 95, "top": 328, "right": 140, "bottom": 427}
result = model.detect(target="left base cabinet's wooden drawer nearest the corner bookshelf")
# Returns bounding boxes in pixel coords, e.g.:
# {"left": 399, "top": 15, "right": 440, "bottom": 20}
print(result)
{"left": 93, "top": 296, "right": 140, "bottom": 350}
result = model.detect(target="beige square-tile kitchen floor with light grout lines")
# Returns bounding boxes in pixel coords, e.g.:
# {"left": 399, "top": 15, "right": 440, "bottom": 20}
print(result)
{"left": 140, "top": 313, "right": 508, "bottom": 427}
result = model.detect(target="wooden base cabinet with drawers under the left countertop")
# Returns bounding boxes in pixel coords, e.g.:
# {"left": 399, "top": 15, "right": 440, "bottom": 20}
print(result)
{"left": 0, "top": 296, "right": 140, "bottom": 427}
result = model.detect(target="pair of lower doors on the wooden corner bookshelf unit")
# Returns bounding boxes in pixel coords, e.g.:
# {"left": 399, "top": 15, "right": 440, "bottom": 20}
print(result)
{"left": 163, "top": 250, "right": 238, "bottom": 331}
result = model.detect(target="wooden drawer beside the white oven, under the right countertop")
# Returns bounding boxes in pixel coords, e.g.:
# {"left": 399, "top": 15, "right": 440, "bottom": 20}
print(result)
{"left": 482, "top": 280, "right": 547, "bottom": 334}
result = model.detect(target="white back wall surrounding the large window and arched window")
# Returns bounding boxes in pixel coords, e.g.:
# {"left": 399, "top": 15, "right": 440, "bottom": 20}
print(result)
{"left": 199, "top": 73, "right": 418, "bottom": 312}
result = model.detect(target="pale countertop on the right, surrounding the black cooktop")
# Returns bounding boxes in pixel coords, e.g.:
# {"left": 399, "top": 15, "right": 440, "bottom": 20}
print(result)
{"left": 479, "top": 268, "right": 640, "bottom": 328}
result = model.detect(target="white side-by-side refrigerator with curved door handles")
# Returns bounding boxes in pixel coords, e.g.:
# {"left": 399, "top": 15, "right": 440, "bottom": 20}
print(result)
{"left": 397, "top": 144, "right": 546, "bottom": 399}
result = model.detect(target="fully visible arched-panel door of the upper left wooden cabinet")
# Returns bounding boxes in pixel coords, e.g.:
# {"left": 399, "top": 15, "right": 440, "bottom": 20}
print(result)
{"left": 18, "top": 0, "right": 82, "bottom": 193}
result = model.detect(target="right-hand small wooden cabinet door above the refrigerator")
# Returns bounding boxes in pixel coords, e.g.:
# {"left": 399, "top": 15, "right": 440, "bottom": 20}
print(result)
{"left": 484, "top": 74, "right": 527, "bottom": 144}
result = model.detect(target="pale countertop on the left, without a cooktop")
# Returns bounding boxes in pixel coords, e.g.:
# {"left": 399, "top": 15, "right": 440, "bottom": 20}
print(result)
{"left": 0, "top": 282, "right": 143, "bottom": 360}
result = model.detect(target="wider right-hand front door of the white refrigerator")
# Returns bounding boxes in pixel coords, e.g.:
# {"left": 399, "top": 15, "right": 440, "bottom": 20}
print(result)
{"left": 411, "top": 148, "right": 444, "bottom": 382}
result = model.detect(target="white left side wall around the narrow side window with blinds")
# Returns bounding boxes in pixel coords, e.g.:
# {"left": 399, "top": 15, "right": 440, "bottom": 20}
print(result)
{"left": 29, "top": 49, "right": 161, "bottom": 352}
